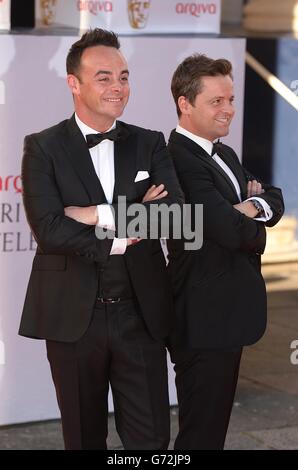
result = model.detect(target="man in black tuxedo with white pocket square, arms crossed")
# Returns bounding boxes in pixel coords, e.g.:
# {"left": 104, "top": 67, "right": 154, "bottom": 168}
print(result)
{"left": 20, "top": 29, "right": 183, "bottom": 449}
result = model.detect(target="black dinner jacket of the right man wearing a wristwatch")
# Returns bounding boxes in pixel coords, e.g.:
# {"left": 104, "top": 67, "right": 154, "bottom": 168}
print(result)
{"left": 168, "top": 131, "right": 284, "bottom": 348}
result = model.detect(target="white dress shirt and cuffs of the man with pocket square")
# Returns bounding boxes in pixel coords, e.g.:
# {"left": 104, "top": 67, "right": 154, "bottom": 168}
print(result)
{"left": 75, "top": 114, "right": 127, "bottom": 255}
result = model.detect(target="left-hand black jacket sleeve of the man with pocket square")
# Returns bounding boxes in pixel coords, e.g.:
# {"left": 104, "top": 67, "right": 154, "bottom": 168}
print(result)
{"left": 22, "top": 135, "right": 113, "bottom": 263}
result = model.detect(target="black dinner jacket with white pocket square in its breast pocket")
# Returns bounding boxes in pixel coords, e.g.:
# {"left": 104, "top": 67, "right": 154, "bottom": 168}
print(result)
{"left": 19, "top": 116, "right": 183, "bottom": 341}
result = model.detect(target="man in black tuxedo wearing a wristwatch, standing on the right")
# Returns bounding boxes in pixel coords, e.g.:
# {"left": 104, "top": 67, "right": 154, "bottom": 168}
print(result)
{"left": 168, "top": 55, "right": 284, "bottom": 449}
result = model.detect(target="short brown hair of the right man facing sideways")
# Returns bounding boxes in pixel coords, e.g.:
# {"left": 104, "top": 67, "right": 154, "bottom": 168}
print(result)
{"left": 171, "top": 54, "right": 233, "bottom": 117}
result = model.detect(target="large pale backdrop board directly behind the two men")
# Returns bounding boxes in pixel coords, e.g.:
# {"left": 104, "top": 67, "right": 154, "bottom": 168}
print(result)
{"left": 0, "top": 34, "right": 245, "bottom": 425}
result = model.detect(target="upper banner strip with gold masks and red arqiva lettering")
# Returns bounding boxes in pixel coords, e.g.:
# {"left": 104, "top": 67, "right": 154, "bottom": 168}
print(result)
{"left": 35, "top": 0, "right": 221, "bottom": 34}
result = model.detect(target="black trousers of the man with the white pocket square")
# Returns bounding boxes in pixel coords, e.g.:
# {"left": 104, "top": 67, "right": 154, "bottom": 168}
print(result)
{"left": 47, "top": 300, "right": 170, "bottom": 450}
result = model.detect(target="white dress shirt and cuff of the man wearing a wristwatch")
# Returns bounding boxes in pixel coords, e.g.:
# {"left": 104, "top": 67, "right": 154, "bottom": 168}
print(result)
{"left": 176, "top": 125, "right": 273, "bottom": 222}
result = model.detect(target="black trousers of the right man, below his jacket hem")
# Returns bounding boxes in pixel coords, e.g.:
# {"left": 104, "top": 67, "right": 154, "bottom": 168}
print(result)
{"left": 171, "top": 348, "right": 242, "bottom": 450}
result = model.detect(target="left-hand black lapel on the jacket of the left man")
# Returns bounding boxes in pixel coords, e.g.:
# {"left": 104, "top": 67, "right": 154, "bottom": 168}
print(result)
{"left": 62, "top": 115, "right": 107, "bottom": 205}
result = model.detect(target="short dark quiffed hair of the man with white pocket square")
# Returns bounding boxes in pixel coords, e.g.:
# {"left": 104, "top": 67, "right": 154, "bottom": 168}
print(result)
{"left": 66, "top": 28, "right": 120, "bottom": 75}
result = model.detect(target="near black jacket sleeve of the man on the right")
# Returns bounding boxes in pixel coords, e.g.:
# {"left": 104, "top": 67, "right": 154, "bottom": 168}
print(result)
{"left": 175, "top": 152, "right": 266, "bottom": 254}
